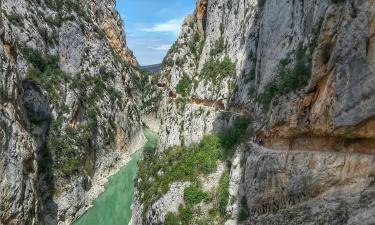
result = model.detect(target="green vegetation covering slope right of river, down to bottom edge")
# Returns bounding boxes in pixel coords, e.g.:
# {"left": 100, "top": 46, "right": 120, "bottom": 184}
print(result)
{"left": 137, "top": 118, "right": 249, "bottom": 224}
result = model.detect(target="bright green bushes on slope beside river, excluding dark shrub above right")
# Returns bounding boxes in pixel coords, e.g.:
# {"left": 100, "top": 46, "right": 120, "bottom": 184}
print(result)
{"left": 137, "top": 135, "right": 224, "bottom": 216}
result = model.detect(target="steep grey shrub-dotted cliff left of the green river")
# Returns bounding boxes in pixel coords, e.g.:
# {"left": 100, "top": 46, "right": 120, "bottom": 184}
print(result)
{"left": 0, "top": 0, "right": 143, "bottom": 225}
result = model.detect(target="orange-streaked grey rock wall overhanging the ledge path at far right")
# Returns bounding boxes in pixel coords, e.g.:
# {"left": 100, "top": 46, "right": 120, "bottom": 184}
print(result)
{"left": 258, "top": 1, "right": 374, "bottom": 153}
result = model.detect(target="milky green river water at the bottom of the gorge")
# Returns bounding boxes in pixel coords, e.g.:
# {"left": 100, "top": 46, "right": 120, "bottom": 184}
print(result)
{"left": 74, "top": 128, "right": 159, "bottom": 225}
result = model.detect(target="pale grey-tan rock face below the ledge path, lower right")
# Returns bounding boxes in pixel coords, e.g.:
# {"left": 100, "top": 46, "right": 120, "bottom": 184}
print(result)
{"left": 243, "top": 145, "right": 375, "bottom": 224}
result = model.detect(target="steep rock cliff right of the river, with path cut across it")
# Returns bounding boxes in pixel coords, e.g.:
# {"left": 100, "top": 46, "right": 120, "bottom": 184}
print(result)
{"left": 137, "top": 0, "right": 375, "bottom": 224}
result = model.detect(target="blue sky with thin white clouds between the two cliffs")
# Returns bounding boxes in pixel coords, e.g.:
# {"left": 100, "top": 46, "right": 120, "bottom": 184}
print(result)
{"left": 117, "top": 0, "right": 196, "bottom": 65}
